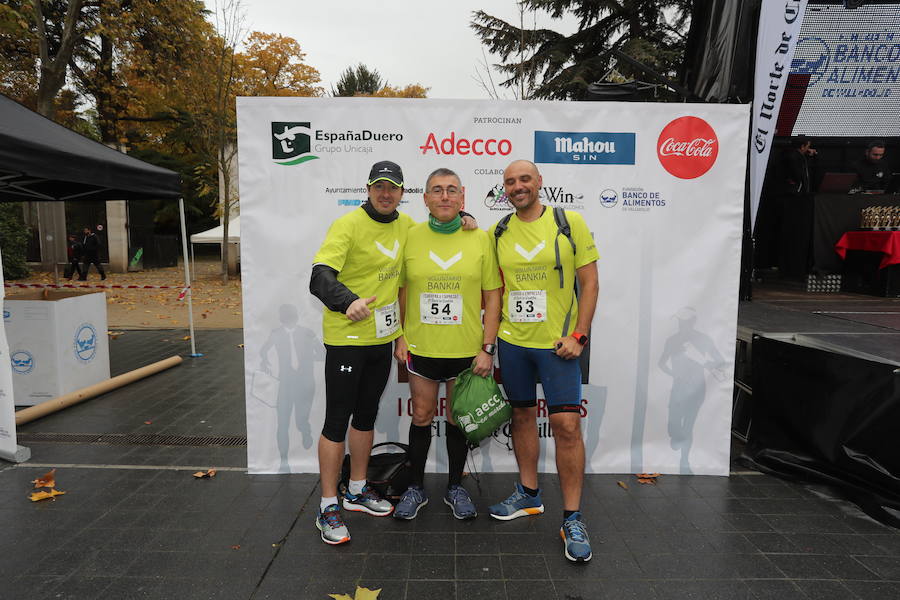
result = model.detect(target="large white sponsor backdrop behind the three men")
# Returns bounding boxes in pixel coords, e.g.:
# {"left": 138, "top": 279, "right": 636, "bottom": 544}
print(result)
{"left": 238, "top": 98, "right": 749, "bottom": 475}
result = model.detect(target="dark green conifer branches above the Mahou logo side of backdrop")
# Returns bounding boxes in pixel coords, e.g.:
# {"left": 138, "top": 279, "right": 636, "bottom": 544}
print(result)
{"left": 471, "top": 0, "right": 692, "bottom": 100}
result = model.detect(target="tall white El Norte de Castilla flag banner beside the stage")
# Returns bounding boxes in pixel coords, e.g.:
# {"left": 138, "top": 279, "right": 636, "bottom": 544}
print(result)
{"left": 750, "top": 0, "right": 806, "bottom": 230}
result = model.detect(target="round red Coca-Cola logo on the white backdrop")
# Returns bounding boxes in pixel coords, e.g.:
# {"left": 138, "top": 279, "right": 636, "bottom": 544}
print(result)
{"left": 656, "top": 117, "right": 719, "bottom": 179}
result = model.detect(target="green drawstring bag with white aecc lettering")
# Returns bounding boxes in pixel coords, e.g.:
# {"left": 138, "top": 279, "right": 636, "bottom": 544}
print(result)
{"left": 453, "top": 368, "right": 512, "bottom": 444}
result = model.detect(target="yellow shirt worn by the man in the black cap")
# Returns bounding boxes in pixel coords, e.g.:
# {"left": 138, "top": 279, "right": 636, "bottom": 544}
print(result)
{"left": 313, "top": 208, "right": 413, "bottom": 346}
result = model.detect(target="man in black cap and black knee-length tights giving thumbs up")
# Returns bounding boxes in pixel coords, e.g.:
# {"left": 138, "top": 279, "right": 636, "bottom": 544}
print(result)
{"left": 309, "top": 161, "right": 413, "bottom": 544}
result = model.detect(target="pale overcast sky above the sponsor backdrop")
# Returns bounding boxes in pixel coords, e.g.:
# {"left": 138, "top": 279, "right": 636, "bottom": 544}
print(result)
{"left": 205, "top": 0, "right": 577, "bottom": 99}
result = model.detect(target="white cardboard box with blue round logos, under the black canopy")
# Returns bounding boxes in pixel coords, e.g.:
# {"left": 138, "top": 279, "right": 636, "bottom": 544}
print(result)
{"left": 3, "top": 290, "right": 109, "bottom": 406}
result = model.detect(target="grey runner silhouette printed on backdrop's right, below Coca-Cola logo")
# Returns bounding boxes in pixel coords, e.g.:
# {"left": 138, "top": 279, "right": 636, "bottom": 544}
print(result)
{"left": 658, "top": 307, "right": 725, "bottom": 475}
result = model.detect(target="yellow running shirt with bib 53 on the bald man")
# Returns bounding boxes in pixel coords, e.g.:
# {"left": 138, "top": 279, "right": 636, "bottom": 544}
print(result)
{"left": 489, "top": 206, "right": 599, "bottom": 349}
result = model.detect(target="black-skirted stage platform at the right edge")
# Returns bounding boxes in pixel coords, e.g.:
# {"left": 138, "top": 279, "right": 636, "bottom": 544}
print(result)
{"left": 732, "top": 284, "right": 900, "bottom": 527}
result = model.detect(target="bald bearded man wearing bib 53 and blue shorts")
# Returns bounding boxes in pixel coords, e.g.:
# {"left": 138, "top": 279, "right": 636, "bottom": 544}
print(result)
{"left": 489, "top": 160, "right": 598, "bottom": 562}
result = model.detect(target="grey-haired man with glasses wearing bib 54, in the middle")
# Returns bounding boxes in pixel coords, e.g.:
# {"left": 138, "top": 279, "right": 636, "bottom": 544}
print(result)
{"left": 394, "top": 169, "right": 502, "bottom": 520}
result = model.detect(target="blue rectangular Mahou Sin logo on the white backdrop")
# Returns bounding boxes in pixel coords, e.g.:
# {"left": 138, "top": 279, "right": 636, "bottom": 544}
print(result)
{"left": 534, "top": 131, "right": 635, "bottom": 165}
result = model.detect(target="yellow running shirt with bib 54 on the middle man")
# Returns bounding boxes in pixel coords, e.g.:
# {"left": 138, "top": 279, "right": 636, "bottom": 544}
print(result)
{"left": 401, "top": 223, "right": 502, "bottom": 358}
